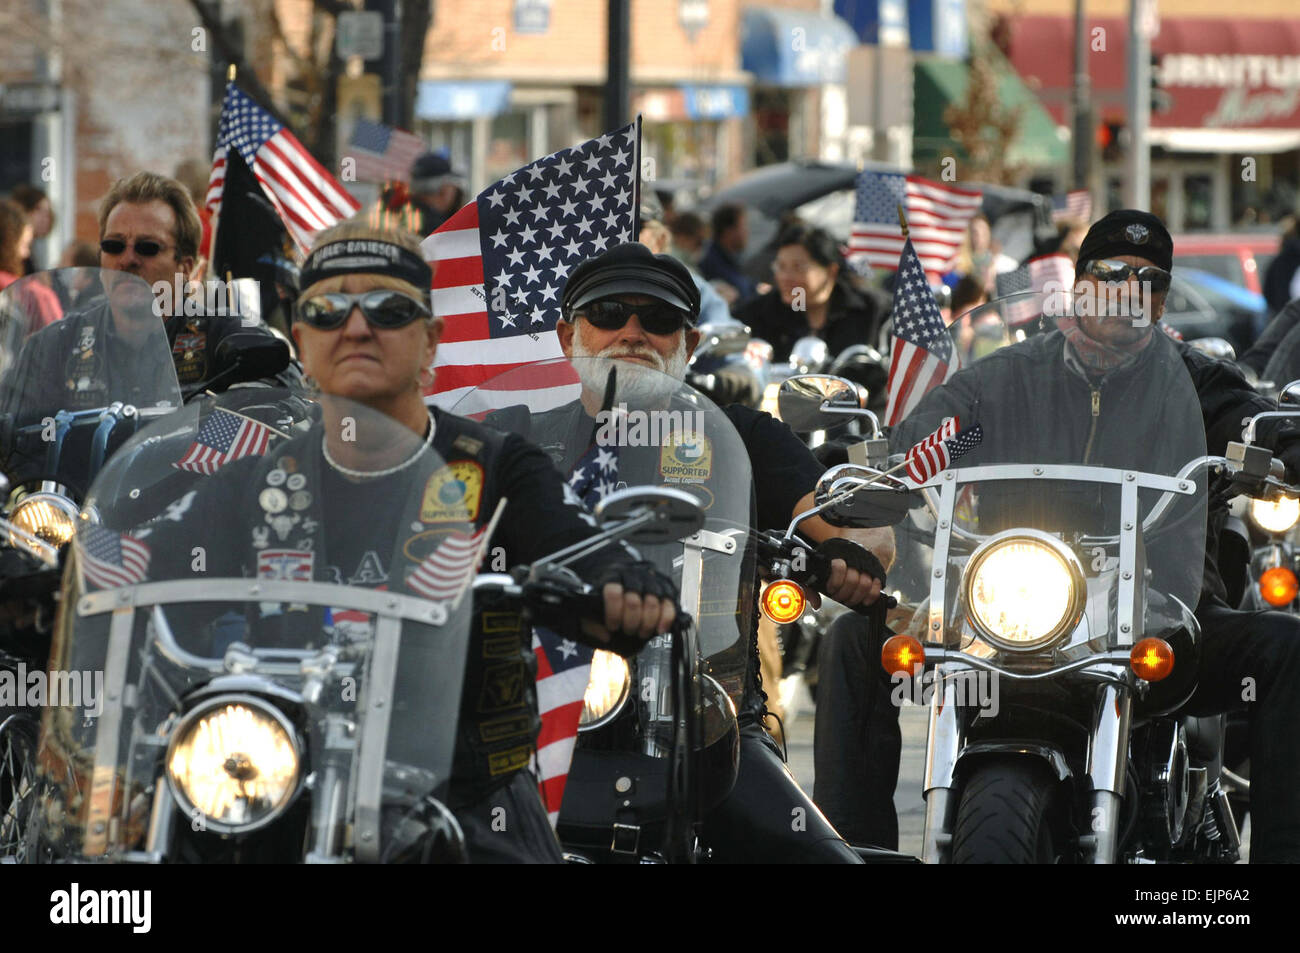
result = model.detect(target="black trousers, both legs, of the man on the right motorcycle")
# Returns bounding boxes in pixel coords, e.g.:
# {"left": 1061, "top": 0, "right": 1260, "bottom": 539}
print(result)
{"left": 813, "top": 597, "right": 1300, "bottom": 863}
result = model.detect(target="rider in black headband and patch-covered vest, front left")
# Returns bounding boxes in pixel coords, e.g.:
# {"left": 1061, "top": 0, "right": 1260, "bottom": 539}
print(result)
{"left": 138, "top": 221, "right": 676, "bottom": 862}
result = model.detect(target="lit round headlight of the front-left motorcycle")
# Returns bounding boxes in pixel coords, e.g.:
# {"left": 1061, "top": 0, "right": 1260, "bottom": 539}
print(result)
{"left": 166, "top": 696, "right": 302, "bottom": 833}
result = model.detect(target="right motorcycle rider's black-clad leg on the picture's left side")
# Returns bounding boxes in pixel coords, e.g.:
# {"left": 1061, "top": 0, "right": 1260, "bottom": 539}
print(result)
{"left": 813, "top": 612, "right": 902, "bottom": 850}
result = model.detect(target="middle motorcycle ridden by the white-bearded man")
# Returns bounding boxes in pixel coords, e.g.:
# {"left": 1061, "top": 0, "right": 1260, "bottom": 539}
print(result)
{"left": 452, "top": 358, "right": 757, "bottom": 863}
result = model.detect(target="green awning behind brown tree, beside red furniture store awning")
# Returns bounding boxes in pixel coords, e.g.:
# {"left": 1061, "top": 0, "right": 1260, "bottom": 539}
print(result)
{"left": 911, "top": 59, "right": 1070, "bottom": 169}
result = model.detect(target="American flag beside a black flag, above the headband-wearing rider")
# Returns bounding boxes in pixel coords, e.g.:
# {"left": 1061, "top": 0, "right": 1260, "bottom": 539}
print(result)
{"left": 207, "top": 83, "right": 361, "bottom": 252}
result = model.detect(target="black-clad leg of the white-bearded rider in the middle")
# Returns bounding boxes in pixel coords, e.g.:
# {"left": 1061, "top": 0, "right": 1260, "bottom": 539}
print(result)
{"left": 701, "top": 718, "right": 862, "bottom": 863}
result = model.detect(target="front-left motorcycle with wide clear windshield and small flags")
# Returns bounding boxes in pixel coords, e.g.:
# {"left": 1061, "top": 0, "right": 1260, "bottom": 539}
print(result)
{"left": 10, "top": 382, "right": 692, "bottom": 863}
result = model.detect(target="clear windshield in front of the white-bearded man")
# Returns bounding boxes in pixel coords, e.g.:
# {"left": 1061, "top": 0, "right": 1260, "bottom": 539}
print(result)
{"left": 451, "top": 358, "right": 757, "bottom": 699}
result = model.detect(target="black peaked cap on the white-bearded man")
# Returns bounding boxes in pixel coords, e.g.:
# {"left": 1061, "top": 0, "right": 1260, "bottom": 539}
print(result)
{"left": 560, "top": 242, "right": 699, "bottom": 324}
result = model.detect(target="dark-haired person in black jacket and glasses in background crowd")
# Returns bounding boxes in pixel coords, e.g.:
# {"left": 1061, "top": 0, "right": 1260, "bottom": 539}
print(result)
{"left": 732, "top": 224, "right": 889, "bottom": 361}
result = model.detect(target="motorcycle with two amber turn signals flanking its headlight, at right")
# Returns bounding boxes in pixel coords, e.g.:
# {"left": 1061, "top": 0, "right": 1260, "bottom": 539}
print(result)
{"left": 785, "top": 295, "right": 1283, "bottom": 863}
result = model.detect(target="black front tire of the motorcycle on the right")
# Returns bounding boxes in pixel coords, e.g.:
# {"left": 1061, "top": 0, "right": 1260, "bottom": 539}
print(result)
{"left": 953, "top": 758, "right": 1069, "bottom": 863}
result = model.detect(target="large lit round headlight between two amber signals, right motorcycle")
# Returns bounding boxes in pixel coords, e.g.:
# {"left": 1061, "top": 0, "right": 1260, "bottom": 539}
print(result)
{"left": 962, "top": 529, "right": 1088, "bottom": 651}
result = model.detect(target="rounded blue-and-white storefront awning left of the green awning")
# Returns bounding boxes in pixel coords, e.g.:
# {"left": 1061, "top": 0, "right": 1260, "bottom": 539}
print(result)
{"left": 740, "top": 7, "right": 858, "bottom": 86}
